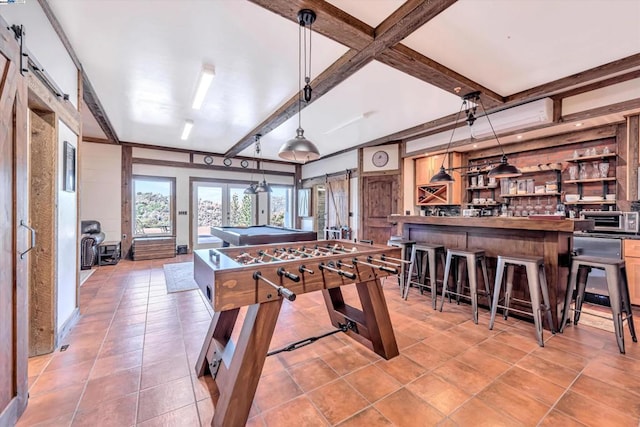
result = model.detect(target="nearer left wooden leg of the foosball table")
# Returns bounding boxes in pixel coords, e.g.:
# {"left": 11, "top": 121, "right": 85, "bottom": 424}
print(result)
{"left": 196, "top": 298, "right": 282, "bottom": 427}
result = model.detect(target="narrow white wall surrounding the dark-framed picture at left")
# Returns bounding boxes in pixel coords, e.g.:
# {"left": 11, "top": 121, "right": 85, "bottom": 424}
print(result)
{"left": 56, "top": 121, "right": 78, "bottom": 330}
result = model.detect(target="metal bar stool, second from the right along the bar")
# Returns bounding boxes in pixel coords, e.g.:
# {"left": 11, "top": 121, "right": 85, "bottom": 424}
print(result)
{"left": 489, "top": 255, "right": 553, "bottom": 347}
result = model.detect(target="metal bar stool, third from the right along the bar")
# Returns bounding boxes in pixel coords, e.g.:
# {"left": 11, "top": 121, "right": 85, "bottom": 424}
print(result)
{"left": 440, "top": 249, "right": 491, "bottom": 325}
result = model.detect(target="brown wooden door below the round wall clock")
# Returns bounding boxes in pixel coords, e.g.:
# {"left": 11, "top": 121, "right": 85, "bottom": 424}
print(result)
{"left": 360, "top": 175, "right": 400, "bottom": 244}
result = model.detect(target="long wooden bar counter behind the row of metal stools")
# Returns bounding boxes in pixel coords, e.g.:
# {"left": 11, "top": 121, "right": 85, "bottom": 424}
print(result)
{"left": 388, "top": 215, "right": 594, "bottom": 329}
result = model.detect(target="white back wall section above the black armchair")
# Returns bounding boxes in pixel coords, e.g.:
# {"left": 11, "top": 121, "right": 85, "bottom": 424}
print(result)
{"left": 78, "top": 142, "right": 122, "bottom": 241}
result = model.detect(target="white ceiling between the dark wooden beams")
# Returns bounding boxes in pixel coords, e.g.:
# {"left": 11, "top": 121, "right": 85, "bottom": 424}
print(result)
{"left": 48, "top": 0, "right": 640, "bottom": 159}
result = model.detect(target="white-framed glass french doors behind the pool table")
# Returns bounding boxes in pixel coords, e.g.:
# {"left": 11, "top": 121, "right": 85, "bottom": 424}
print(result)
{"left": 191, "top": 181, "right": 256, "bottom": 249}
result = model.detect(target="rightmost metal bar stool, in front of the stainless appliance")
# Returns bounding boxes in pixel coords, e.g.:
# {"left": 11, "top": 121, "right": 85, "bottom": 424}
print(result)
{"left": 560, "top": 256, "right": 638, "bottom": 354}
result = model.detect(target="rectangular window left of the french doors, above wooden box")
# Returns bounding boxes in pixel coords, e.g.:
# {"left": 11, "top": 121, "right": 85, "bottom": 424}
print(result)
{"left": 133, "top": 176, "right": 175, "bottom": 237}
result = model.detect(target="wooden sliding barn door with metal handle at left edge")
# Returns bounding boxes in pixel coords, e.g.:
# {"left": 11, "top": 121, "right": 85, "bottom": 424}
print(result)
{"left": 0, "top": 18, "right": 29, "bottom": 426}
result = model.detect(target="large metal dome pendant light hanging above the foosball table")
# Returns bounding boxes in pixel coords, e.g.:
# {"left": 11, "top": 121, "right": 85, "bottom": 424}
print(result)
{"left": 278, "top": 9, "right": 320, "bottom": 163}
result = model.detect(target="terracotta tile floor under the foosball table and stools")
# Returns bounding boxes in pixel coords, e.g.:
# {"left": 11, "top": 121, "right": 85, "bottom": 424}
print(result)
{"left": 18, "top": 255, "right": 640, "bottom": 427}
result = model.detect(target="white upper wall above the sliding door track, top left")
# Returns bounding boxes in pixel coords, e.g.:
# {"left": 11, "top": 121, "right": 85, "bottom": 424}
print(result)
{"left": 0, "top": 0, "right": 78, "bottom": 108}
